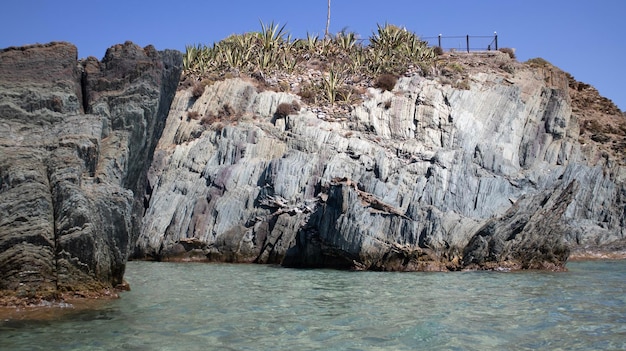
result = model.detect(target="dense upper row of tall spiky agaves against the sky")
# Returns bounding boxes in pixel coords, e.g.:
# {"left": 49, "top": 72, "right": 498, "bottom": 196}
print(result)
{"left": 183, "top": 22, "right": 437, "bottom": 76}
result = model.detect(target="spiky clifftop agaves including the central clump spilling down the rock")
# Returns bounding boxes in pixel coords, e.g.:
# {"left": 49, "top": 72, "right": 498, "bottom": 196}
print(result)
{"left": 183, "top": 22, "right": 437, "bottom": 105}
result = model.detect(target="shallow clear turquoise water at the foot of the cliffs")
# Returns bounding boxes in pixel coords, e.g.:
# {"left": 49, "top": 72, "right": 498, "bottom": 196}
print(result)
{"left": 0, "top": 261, "right": 626, "bottom": 350}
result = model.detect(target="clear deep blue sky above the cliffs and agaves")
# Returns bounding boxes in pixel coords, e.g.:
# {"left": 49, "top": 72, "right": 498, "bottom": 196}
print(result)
{"left": 0, "top": 0, "right": 626, "bottom": 110}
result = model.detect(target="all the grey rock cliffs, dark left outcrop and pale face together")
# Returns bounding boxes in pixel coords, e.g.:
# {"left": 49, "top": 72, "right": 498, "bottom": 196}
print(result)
{"left": 0, "top": 42, "right": 626, "bottom": 304}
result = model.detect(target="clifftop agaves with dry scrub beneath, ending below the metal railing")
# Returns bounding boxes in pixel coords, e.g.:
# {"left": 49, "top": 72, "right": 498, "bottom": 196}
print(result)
{"left": 181, "top": 22, "right": 516, "bottom": 114}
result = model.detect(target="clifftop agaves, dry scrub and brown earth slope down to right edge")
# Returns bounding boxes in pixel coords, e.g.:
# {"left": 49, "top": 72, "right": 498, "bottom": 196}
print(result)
{"left": 181, "top": 22, "right": 626, "bottom": 162}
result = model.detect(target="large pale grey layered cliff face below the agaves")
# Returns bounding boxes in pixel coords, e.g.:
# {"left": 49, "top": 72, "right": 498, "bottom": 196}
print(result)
{"left": 135, "top": 54, "right": 626, "bottom": 270}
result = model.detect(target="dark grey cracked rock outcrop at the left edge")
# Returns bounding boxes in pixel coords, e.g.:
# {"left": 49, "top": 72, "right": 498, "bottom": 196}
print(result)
{"left": 0, "top": 43, "right": 182, "bottom": 297}
